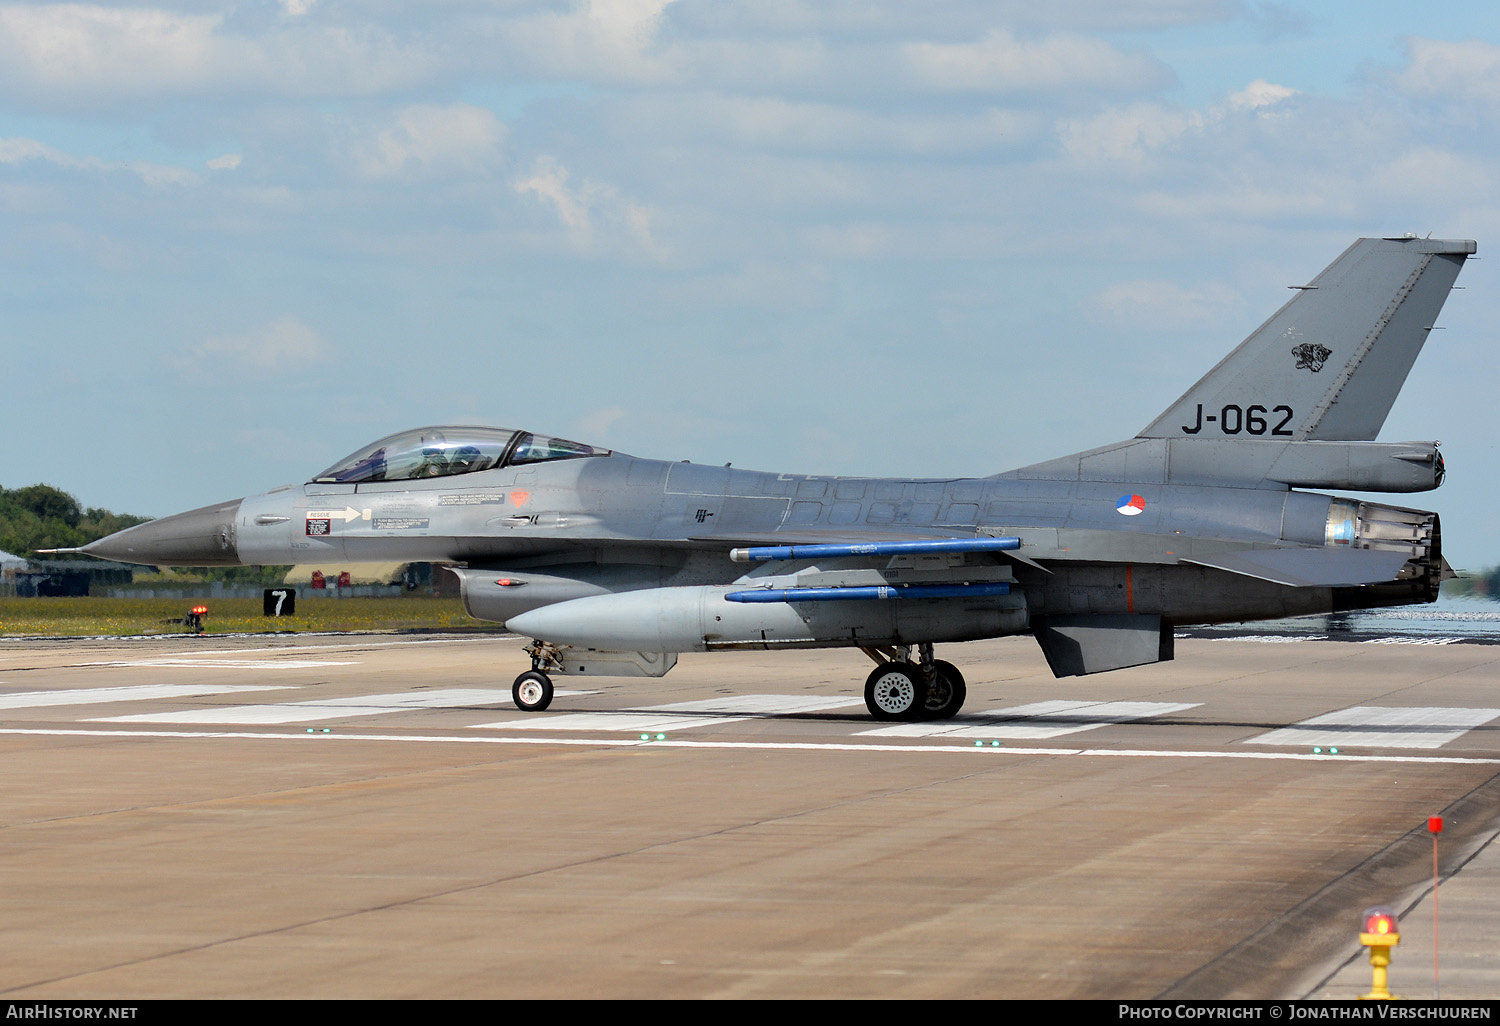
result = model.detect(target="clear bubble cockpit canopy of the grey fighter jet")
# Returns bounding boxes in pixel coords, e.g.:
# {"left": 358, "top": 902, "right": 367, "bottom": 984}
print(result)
{"left": 312, "top": 428, "right": 611, "bottom": 485}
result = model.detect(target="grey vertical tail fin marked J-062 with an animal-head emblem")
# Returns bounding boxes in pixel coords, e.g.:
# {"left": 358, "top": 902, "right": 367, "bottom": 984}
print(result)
{"left": 1139, "top": 239, "right": 1475, "bottom": 441}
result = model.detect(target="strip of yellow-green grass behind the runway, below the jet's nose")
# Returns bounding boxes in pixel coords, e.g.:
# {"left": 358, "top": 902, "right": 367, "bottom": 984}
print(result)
{"left": 0, "top": 597, "right": 486, "bottom": 638}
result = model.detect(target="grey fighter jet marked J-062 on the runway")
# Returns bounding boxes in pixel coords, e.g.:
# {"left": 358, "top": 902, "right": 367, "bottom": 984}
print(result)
{"left": 83, "top": 237, "right": 1475, "bottom": 720}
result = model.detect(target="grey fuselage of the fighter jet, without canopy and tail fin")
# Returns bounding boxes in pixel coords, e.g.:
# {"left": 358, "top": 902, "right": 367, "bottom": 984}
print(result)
{"left": 92, "top": 453, "right": 1436, "bottom": 636}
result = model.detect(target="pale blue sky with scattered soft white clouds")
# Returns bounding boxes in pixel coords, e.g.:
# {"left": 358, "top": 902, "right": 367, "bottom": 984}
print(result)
{"left": 0, "top": 0, "right": 1500, "bottom": 569}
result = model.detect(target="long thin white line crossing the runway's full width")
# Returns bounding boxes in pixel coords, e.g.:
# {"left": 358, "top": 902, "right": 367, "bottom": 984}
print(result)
{"left": 0, "top": 728, "right": 1500, "bottom": 767}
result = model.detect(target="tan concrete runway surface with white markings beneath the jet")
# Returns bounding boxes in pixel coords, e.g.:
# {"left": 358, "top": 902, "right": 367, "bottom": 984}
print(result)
{"left": 0, "top": 635, "right": 1500, "bottom": 999}
